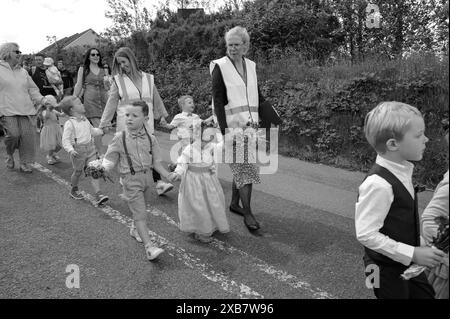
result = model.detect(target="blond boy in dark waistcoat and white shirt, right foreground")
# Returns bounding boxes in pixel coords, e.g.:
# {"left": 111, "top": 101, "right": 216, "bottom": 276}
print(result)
{"left": 355, "top": 102, "right": 444, "bottom": 299}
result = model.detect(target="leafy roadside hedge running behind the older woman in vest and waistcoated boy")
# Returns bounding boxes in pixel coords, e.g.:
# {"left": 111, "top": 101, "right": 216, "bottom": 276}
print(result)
{"left": 149, "top": 56, "right": 449, "bottom": 187}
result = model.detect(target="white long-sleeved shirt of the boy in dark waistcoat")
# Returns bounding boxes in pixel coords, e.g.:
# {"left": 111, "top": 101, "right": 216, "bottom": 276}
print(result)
{"left": 355, "top": 155, "right": 414, "bottom": 266}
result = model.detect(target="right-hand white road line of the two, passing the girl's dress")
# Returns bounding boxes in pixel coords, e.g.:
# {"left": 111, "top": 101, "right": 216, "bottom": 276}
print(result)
{"left": 147, "top": 207, "right": 337, "bottom": 299}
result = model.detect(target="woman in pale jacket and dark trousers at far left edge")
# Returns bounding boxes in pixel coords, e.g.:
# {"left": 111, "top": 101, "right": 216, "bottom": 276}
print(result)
{"left": 0, "top": 43, "right": 44, "bottom": 173}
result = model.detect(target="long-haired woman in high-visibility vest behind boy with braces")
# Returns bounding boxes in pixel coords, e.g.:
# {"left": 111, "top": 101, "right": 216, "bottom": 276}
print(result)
{"left": 99, "top": 47, "right": 173, "bottom": 195}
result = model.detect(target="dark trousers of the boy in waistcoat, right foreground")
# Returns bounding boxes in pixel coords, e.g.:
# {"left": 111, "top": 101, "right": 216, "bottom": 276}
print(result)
{"left": 374, "top": 266, "right": 435, "bottom": 299}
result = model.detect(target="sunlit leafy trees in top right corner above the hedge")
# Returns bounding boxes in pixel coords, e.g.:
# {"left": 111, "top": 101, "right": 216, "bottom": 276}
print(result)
{"left": 328, "top": 0, "right": 448, "bottom": 61}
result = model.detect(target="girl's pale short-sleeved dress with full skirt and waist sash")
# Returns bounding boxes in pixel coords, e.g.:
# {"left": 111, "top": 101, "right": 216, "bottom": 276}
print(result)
{"left": 175, "top": 139, "right": 230, "bottom": 236}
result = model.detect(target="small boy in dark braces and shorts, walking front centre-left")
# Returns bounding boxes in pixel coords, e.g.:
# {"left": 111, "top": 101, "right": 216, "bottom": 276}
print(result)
{"left": 102, "top": 101, "right": 169, "bottom": 260}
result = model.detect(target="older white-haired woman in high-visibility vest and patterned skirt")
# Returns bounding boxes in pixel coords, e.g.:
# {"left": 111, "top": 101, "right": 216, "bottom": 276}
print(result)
{"left": 210, "top": 26, "right": 264, "bottom": 231}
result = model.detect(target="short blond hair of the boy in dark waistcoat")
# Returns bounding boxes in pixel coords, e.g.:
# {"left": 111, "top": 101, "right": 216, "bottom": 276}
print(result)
{"left": 364, "top": 101, "right": 422, "bottom": 154}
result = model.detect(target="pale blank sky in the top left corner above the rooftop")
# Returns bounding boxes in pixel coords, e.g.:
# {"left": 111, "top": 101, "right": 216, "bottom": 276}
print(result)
{"left": 0, "top": 0, "right": 193, "bottom": 54}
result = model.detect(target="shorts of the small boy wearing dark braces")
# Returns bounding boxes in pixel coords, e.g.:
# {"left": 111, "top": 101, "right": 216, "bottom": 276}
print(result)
{"left": 120, "top": 168, "right": 154, "bottom": 221}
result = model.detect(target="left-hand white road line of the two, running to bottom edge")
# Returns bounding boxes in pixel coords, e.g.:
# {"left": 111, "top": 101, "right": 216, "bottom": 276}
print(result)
{"left": 31, "top": 163, "right": 264, "bottom": 299}
